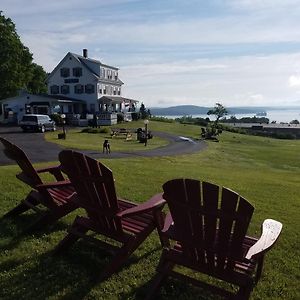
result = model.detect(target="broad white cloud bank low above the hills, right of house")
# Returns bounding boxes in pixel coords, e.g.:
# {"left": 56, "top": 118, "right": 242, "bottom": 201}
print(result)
{"left": 120, "top": 53, "right": 300, "bottom": 106}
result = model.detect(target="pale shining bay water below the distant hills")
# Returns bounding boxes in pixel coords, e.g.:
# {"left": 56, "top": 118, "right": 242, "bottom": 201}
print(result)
{"left": 163, "top": 109, "right": 300, "bottom": 123}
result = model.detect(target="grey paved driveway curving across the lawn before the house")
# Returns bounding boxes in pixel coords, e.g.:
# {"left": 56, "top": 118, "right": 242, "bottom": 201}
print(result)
{"left": 0, "top": 127, "right": 206, "bottom": 166}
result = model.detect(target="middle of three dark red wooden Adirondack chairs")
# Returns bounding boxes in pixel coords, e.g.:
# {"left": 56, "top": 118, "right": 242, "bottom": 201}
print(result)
{"left": 55, "top": 150, "right": 165, "bottom": 280}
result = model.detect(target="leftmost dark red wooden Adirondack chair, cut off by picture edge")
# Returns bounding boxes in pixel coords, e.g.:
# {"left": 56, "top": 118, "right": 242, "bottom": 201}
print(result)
{"left": 0, "top": 137, "right": 77, "bottom": 229}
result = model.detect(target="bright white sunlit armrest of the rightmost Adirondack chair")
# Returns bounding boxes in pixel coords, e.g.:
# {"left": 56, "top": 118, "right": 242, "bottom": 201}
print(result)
{"left": 245, "top": 219, "right": 282, "bottom": 260}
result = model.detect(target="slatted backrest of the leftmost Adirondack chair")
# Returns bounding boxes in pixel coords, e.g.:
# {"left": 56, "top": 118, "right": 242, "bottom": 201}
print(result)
{"left": 0, "top": 137, "right": 43, "bottom": 188}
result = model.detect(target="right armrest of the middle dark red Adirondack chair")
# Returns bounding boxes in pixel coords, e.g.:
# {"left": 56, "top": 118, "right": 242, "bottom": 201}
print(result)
{"left": 117, "top": 193, "right": 166, "bottom": 218}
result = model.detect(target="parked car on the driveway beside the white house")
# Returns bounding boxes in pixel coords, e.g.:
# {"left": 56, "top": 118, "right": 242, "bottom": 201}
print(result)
{"left": 19, "top": 114, "right": 56, "bottom": 132}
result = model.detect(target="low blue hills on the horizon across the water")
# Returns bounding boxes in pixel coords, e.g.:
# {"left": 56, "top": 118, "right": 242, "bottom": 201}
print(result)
{"left": 150, "top": 105, "right": 267, "bottom": 116}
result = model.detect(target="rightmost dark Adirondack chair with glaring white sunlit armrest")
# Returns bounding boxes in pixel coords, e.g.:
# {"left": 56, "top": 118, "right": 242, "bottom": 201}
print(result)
{"left": 147, "top": 179, "right": 282, "bottom": 299}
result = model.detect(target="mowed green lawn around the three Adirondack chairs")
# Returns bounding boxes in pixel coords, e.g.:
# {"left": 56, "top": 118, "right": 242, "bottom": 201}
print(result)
{"left": 0, "top": 122, "right": 300, "bottom": 300}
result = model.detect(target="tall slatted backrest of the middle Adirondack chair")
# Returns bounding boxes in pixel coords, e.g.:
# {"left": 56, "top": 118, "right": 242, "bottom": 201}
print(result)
{"left": 59, "top": 150, "right": 123, "bottom": 233}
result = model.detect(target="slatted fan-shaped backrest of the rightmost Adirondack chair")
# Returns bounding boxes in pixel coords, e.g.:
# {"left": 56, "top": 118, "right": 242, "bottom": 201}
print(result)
{"left": 163, "top": 179, "right": 254, "bottom": 270}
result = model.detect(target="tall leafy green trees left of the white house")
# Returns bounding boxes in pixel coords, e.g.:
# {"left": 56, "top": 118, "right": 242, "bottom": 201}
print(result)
{"left": 0, "top": 11, "right": 46, "bottom": 99}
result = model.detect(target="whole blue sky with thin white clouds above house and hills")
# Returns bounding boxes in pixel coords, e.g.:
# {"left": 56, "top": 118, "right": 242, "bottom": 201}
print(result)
{"left": 0, "top": 0, "right": 300, "bottom": 107}
